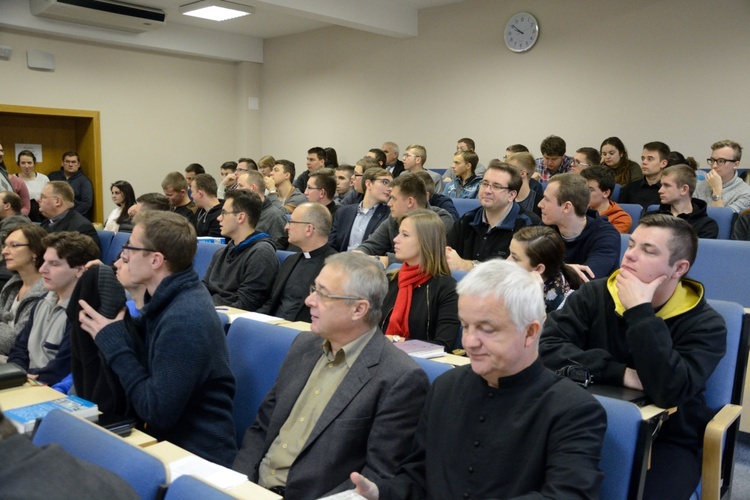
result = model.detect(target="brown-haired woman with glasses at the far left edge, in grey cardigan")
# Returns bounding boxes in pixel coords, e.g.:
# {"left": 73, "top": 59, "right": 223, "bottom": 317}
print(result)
{"left": 0, "top": 224, "right": 47, "bottom": 358}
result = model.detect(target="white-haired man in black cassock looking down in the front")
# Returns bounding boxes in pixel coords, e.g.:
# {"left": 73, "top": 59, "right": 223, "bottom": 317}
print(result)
{"left": 351, "top": 259, "right": 607, "bottom": 499}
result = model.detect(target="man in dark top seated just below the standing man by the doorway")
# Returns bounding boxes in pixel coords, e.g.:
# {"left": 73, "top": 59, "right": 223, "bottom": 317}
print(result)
{"left": 39, "top": 181, "right": 100, "bottom": 246}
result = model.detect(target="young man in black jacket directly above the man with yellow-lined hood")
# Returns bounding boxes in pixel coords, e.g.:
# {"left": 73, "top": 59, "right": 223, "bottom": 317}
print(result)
{"left": 659, "top": 165, "right": 719, "bottom": 239}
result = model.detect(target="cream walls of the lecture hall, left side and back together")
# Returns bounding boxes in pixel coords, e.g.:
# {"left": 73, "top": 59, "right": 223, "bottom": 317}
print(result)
{"left": 0, "top": 0, "right": 750, "bottom": 219}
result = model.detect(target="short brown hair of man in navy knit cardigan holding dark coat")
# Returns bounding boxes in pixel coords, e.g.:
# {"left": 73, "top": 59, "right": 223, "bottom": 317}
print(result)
{"left": 133, "top": 210, "right": 198, "bottom": 273}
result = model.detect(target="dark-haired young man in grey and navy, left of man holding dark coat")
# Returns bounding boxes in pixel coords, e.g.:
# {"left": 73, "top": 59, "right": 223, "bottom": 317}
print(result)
{"left": 8, "top": 232, "right": 99, "bottom": 385}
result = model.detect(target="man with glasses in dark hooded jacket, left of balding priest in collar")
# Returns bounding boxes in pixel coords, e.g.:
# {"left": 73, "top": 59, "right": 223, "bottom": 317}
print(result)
{"left": 203, "top": 189, "right": 279, "bottom": 311}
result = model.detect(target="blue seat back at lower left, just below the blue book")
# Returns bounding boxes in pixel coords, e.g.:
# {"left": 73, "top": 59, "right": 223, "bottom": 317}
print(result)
{"left": 33, "top": 410, "right": 167, "bottom": 498}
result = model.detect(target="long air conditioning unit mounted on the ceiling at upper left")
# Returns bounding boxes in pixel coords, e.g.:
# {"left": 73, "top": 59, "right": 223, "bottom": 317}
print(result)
{"left": 29, "top": 0, "right": 167, "bottom": 33}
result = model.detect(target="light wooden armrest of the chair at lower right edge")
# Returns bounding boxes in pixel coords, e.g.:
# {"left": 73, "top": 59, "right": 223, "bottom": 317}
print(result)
{"left": 701, "top": 404, "right": 742, "bottom": 500}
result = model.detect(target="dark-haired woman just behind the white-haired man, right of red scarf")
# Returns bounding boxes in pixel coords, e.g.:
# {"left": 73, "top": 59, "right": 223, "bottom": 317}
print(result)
{"left": 508, "top": 226, "right": 582, "bottom": 313}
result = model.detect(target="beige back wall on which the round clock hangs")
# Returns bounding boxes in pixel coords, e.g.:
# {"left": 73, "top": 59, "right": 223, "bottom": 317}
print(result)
{"left": 262, "top": 0, "right": 750, "bottom": 168}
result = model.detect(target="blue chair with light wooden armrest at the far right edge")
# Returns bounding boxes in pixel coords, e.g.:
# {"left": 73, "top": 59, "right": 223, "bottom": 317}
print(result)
{"left": 691, "top": 300, "right": 750, "bottom": 499}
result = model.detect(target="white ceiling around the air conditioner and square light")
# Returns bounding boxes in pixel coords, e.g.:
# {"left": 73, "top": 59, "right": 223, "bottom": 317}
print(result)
{"left": 0, "top": 0, "right": 462, "bottom": 62}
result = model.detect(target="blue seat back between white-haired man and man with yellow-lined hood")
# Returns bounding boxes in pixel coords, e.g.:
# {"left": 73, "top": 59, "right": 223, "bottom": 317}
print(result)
{"left": 594, "top": 396, "right": 643, "bottom": 499}
